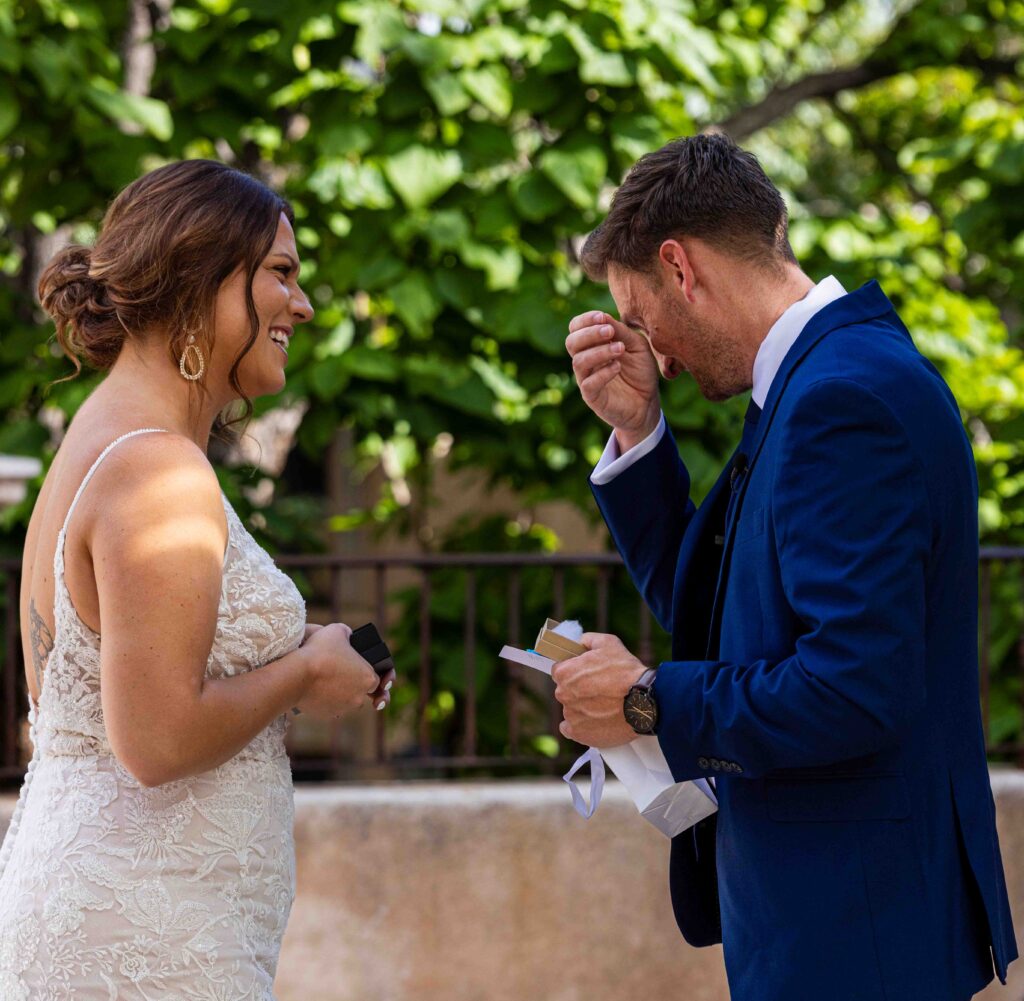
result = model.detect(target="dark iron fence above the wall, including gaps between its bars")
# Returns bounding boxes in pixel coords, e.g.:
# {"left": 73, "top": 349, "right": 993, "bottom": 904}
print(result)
{"left": 0, "top": 548, "right": 1024, "bottom": 787}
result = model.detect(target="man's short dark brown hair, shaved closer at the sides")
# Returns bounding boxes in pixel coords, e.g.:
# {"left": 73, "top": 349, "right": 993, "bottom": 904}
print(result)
{"left": 580, "top": 134, "right": 797, "bottom": 281}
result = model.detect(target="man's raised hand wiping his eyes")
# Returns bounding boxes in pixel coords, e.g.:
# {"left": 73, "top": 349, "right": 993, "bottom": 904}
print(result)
{"left": 565, "top": 312, "right": 662, "bottom": 451}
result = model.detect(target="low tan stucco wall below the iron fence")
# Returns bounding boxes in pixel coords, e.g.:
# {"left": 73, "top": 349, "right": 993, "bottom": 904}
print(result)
{"left": 0, "top": 770, "right": 1024, "bottom": 1001}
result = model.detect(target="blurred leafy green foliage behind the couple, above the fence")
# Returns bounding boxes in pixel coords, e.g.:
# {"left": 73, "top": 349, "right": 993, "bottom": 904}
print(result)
{"left": 0, "top": 0, "right": 1024, "bottom": 761}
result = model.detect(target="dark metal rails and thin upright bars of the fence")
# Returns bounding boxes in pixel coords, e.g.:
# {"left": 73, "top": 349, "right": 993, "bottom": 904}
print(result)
{"left": 0, "top": 547, "right": 1024, "bottom": 786}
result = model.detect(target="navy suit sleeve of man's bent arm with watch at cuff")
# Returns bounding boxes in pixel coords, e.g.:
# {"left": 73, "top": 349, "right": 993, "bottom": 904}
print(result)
{"left": 654, "top": 379, "right": 931, "bottom": 781}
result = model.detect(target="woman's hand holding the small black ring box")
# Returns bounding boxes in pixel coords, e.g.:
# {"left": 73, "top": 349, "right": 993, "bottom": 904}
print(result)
{"left": 297, "top": 622, "right": 389, "bottom": 720}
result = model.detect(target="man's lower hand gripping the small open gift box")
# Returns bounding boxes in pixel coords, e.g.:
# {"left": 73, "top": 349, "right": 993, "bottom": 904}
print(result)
{"left": 551, "top": 633, "right": 647, "bottom": 747}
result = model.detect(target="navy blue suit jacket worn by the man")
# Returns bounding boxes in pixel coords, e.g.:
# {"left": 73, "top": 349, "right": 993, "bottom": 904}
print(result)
{"left": 594, "top": 281, "right": 1017, "bottom": 1001}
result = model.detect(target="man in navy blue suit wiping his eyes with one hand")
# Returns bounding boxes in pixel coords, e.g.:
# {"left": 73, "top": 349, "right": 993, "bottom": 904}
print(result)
{"left": 554, "top": 135, "right": 1017, "bottom": 1001}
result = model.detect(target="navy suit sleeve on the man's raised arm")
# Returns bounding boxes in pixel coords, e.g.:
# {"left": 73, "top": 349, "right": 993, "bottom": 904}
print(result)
{"left": 591, "top": 429, "right": 695, "bottom": 632}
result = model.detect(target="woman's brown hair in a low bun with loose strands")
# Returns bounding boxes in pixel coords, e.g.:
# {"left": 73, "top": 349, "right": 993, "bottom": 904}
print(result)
{"left": 39, "top": 160, "right": 295, "bottom": 427}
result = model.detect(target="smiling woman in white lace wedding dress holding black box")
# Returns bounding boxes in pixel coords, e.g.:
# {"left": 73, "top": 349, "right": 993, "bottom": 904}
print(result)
{"left": 0, "top": 161, "right": 393, "bottom": 1001}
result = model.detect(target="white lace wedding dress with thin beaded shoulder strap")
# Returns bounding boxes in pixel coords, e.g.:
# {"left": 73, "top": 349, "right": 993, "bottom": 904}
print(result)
{"left": 0, "top": 428, "right": 305, "bottom": 1001}
